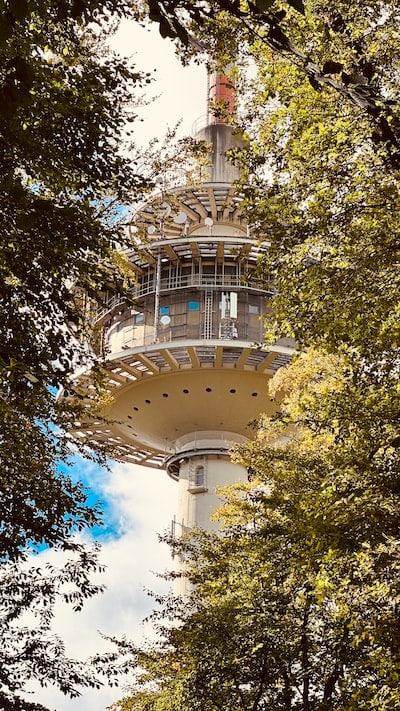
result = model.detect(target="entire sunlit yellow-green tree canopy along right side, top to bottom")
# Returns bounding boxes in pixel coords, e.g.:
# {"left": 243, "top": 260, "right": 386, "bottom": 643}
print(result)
{"left": 108, "top": 0, "right": 400, "bottom": 711}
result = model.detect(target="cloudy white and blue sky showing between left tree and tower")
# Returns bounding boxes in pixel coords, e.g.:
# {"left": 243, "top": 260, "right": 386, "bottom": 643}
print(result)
{"left": 22, "top": 16, "right": 207, "bottom": 711}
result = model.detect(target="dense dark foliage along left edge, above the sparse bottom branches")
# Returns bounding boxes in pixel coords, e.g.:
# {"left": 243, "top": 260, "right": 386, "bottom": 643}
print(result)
{"left": 0, "top": 2, "right": 147, "bottom": 557}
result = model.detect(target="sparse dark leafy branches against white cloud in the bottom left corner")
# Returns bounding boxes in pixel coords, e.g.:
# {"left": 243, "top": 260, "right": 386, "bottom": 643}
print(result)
{"left": 0, "top": 545, "right": 106, "bottom": 711}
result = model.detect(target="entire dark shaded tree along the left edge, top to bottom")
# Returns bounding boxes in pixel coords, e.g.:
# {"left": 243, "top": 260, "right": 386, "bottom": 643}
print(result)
{"left": 0, "top": 0, "right": 153, "bottom": 709}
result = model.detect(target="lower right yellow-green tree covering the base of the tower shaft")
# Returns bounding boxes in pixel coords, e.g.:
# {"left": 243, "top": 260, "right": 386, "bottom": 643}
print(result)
{"left": 111, "top": 352, "right": 400, "bottom": 711}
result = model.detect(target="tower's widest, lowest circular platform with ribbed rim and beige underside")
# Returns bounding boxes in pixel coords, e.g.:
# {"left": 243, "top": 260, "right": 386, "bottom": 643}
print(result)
{"left": 75, "top": 340, "right": 294, "bottom": 467}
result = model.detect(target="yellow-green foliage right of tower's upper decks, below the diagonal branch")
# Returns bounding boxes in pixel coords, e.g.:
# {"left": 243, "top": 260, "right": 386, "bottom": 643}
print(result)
{"left": 234, "top": 11, "right": 399, "bottom": 367}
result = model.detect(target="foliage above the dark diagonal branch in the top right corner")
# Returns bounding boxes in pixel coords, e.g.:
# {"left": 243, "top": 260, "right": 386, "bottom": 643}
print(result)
{"left": 144, "top": 0, "right": 400, "bottom": 168}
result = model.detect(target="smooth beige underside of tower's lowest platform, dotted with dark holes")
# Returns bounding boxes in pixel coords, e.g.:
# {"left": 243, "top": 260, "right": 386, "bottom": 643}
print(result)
{"left": 107, "top": 368, "right": 275, "bottom": 453}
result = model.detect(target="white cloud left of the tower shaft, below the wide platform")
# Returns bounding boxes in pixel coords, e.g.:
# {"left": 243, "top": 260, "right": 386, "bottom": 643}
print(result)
{"left": 23, "top": 464, "right": 177, "bottom": 711}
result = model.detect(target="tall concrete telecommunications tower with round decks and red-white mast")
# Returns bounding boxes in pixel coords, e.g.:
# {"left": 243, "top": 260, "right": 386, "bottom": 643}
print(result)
{"left": 72, "top": 73, "right": 293, "bottom": 533}
